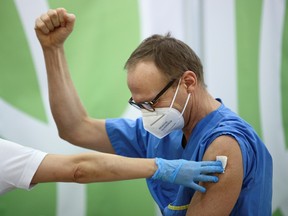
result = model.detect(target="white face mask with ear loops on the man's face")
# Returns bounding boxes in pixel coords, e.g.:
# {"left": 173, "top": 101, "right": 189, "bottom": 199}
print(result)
{"left": 141, "top": 81, "right": 190, "bottom": 139}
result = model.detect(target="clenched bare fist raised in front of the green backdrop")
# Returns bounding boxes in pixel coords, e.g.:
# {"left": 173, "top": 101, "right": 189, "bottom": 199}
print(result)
{"left": 35, "top": 8, "right": 75, "bottom": 48}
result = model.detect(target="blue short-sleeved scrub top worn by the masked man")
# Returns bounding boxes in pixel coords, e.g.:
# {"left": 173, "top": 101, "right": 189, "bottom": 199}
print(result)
{"left": 106, "top": 100, "right": 272, "bottom": 216}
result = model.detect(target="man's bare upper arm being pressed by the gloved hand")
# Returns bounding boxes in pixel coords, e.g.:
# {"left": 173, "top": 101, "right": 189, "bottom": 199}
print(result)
{"left": 187, "top": 136, "right": 243, "bottom": 216}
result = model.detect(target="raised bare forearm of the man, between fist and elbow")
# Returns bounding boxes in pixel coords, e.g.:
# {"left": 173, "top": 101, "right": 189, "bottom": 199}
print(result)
{"left": 43, "top": 46, "right": 87, "bottom": 138}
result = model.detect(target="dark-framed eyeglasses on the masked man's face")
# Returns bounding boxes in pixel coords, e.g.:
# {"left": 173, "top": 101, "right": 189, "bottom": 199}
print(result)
{"left": 128, "top": 79, "right": 176, "bottom": 112}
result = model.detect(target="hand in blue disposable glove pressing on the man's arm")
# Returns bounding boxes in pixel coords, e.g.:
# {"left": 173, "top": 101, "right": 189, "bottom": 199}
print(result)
{"left": 151, "top": 158, "right": 223, "bottom": 193}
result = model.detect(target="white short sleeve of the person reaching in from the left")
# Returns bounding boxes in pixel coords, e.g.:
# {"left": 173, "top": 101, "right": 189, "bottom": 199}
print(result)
{"left": 0, "top": 138, "right": 47, "bottom": 194}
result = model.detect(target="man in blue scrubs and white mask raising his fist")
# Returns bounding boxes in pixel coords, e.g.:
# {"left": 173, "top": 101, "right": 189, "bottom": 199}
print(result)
{"left": 35, "top": 9, "right": 272, "bottom": 216}
